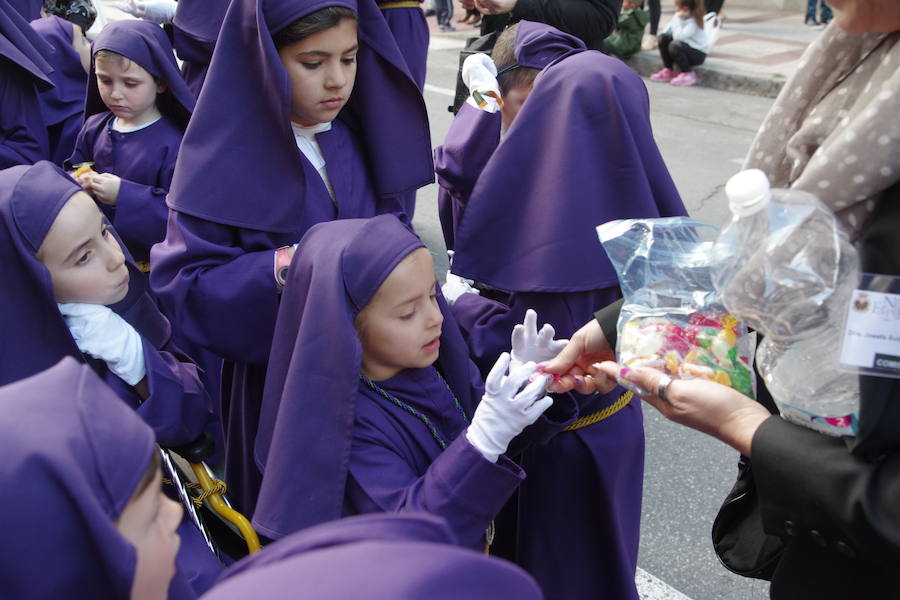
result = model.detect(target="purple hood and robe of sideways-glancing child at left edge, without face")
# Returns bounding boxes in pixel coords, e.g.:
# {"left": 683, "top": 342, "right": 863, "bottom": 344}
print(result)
{"left": 0, "top": 161, "right": 209, "bottom": 445}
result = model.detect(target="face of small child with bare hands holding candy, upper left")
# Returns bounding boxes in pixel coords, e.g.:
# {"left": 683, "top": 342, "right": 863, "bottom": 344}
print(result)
{"left": 94, "top": 56, "right": 166, "bottom": 125}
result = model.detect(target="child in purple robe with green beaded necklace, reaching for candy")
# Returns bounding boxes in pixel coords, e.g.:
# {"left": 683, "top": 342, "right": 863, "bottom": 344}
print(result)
{"left": 253, "top": 215, "right": 574, "bottom": 548}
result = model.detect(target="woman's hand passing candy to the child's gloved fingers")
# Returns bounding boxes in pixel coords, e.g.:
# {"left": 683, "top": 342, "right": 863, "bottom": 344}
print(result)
{"left": 541, "top": 319, "right": 616, "bottom": 394}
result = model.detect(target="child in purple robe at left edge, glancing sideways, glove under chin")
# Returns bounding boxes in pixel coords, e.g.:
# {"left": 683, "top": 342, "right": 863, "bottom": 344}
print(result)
{"left": 0, "top": 161, "right": 222, "bottom": 593}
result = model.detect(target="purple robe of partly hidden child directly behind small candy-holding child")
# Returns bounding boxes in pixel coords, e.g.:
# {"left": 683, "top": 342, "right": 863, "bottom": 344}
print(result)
{"left": 31, "top": 15, "right": 87, "bottom": 166}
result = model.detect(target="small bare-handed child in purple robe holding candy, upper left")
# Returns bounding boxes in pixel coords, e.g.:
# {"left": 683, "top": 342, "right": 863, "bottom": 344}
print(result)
{"left": 66, "top": 20, "right": 194, "bottom": 272}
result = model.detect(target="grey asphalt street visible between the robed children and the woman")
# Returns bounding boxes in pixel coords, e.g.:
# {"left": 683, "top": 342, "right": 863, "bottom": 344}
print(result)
{"left": 415, "top": 35, "right": 772, "bottom": 600}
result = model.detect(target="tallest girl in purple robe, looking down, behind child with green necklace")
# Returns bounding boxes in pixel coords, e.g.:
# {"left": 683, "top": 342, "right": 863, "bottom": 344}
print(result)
{"left": 151, "top": 0, "right": 433, "bottom": 513}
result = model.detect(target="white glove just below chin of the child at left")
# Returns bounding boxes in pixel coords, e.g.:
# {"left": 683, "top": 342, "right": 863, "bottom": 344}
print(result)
{"left": 58, "top": 303, "right": 147, "bottom": 385}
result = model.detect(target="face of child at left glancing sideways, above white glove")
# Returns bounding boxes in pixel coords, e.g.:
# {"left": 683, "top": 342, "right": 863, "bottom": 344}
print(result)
{"left": 37, "top": 192, "right": 128, "bottom": 305}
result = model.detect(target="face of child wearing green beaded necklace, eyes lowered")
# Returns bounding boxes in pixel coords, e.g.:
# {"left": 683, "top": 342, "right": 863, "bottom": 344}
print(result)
{"left": 359, "top": 248, "right": 444, "bottom": 381}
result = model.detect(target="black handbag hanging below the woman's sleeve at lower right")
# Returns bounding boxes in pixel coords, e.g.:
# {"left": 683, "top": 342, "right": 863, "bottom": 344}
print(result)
{"left": 712, "top": 456, "right": 784, "bottom": 581}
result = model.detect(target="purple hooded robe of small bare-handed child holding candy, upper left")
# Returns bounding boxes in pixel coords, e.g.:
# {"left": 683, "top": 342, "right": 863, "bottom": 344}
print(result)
{"left": 66, "top": 19, "right": 194, "bottom": 261}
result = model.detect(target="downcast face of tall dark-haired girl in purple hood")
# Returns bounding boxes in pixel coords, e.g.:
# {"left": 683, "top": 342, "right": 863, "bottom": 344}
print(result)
{"left": 278, "top": 19, "right": 359, "bottom": 127}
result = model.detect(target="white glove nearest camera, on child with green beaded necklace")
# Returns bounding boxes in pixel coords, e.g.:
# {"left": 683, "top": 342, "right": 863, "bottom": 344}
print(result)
{"left": 466, "top": 352, "right": 553, "bottom": 462}
